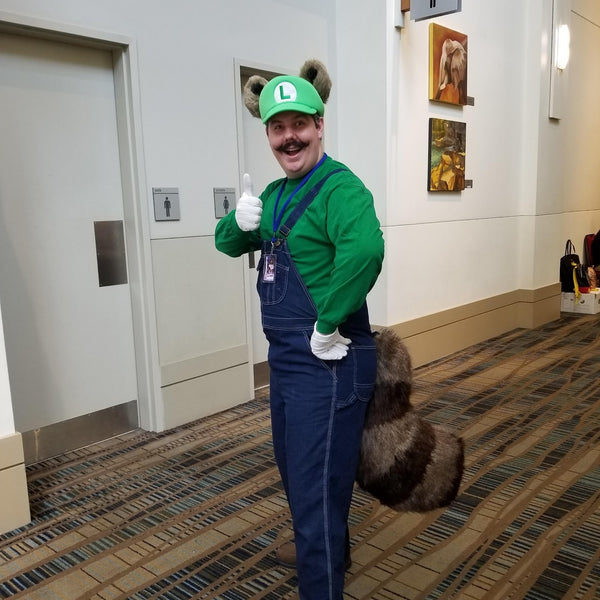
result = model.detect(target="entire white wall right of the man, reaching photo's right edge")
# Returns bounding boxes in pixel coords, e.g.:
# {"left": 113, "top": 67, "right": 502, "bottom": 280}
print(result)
{"left": 378, "top": 0, "right": 600, "bottom": 324}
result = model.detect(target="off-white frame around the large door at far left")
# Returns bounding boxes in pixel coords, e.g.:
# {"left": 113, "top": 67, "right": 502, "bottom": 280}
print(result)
{"left": 0, "top": 11, "right": 164, "bottom": 431}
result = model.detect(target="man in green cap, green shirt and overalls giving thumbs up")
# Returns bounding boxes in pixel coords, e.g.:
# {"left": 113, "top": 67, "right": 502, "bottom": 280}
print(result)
{"left": 215, "top": 71, "right": 384, "bottom": 600}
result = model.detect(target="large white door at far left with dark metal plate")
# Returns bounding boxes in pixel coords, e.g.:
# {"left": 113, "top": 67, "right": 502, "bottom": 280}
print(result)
{"left": 0, "top": 34, "right": 137, "bottom": 462}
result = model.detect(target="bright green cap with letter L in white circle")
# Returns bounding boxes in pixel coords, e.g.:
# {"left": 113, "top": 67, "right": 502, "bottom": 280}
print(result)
{"left": 258, "top": 75, "right": 325, "bottom": 123}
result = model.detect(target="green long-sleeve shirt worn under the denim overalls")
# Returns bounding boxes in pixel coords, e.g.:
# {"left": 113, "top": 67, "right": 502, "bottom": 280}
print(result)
{"left": 215, "top": 157, "right": 384, "bottom": 334}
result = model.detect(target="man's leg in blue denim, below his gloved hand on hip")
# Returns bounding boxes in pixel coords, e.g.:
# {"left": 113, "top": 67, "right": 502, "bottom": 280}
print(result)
{"left": 283, "top": 350, "right": 367, "bottom": 600}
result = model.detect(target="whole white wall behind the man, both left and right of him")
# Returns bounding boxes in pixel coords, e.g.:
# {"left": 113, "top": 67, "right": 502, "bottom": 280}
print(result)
{"left": 0, "top": 0, "right": 600, "bottom": 431}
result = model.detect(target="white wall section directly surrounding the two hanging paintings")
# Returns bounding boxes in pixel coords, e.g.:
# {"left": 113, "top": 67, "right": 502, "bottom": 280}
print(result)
{"left": 386, "top": 0, "right": 539, "bottom": 323}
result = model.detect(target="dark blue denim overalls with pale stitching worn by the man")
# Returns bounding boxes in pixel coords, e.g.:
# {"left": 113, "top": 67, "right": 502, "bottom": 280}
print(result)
{"left": 257, "top": 171, "right": 376, "bottom": 600}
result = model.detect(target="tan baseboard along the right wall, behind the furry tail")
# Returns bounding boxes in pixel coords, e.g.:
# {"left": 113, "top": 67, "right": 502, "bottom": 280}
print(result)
{"left": 254, "top": 283, "right": 560, "bottom": 380}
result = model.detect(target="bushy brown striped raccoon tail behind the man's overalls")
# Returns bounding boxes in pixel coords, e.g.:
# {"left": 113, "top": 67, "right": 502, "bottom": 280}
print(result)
{"left": 356, "top": 329, "right": 464, "bottom": 512}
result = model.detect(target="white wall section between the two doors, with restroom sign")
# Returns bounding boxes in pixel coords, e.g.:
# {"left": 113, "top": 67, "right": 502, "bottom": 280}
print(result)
{"left": 0, "top": 0, "right": 336, "bottom": 429}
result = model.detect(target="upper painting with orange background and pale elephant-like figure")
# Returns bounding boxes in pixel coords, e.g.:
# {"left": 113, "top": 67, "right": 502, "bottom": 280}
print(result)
{"left": 429, "top": 23, "right": 468, "bottom": 106}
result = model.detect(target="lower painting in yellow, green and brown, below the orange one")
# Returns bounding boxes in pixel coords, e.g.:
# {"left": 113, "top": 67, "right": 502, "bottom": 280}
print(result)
{"left": 427, "top": 118, "right": 467, "bottom": 192}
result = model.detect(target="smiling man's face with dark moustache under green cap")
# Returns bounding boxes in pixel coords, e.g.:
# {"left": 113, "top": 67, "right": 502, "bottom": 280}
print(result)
{"left": 267, "top": 111, "right": 323, "bottom": 179}
